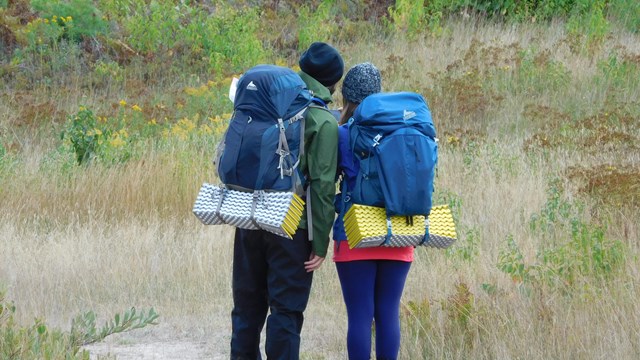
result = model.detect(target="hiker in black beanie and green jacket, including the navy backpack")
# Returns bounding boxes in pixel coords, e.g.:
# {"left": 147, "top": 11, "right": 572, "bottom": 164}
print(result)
{"left": 225, "top": 42, "right": 344, "bottom": 360}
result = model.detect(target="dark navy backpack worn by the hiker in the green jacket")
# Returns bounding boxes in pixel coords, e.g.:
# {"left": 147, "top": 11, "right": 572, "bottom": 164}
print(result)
{"left": 216, "top": 65, "right": 318, "bottom": 195}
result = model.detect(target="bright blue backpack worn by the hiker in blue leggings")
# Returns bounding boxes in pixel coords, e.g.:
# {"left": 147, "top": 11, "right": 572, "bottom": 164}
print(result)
{"left": 349, "top": 92, "right": 438, "bottom": 217}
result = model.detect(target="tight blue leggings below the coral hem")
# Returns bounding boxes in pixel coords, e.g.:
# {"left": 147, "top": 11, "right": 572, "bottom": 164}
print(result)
{"left": 336, "top": 260, "right": 411, "bottom": 360}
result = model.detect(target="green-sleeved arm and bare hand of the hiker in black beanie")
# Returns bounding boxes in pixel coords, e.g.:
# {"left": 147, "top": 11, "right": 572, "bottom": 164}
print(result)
{"left": 305, "top": 110, "right": 338, "bottom": 271}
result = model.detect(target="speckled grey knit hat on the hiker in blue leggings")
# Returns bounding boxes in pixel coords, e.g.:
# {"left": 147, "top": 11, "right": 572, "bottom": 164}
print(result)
{"left": 342, "top": 62, "right": 382, "bottom": 104}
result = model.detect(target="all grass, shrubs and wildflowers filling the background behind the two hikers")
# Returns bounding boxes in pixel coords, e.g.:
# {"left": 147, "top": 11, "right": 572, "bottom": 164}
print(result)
{"left": 0, "top": 0, "right": 640, "bottom": 359}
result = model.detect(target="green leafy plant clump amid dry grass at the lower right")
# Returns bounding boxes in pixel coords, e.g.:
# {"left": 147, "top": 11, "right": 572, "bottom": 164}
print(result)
{"left": 498, "top": 181, "right": 626, "bottom": 290}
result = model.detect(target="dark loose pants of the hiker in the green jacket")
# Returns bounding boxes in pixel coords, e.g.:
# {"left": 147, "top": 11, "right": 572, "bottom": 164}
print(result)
{"left": 231, "top": 229, "right": 313, "bottom": 360}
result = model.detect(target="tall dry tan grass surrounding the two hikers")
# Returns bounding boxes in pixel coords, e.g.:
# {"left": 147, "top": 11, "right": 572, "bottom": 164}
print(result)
{"left": 0, "top": 20, "right": 640, "bottom": 359}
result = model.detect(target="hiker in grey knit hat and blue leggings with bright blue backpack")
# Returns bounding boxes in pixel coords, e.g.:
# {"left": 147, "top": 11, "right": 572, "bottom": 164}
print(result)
{"left": 333, "top": 63, "right": 436, "bottom": 360}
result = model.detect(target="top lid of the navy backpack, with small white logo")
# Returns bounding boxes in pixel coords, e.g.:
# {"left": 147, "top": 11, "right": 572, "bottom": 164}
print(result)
{"left": 234, "top": 65, "right": 312, "bottom": 120}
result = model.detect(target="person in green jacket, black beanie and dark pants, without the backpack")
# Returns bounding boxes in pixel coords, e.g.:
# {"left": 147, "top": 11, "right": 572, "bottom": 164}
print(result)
{"left": 231, "top": 42, "right": 344, "bottom": 360}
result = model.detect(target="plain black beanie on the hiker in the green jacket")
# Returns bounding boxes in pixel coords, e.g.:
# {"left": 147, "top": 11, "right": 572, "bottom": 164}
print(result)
{"left": 298, "top": 42, "right": 344, "bottom": 87}
